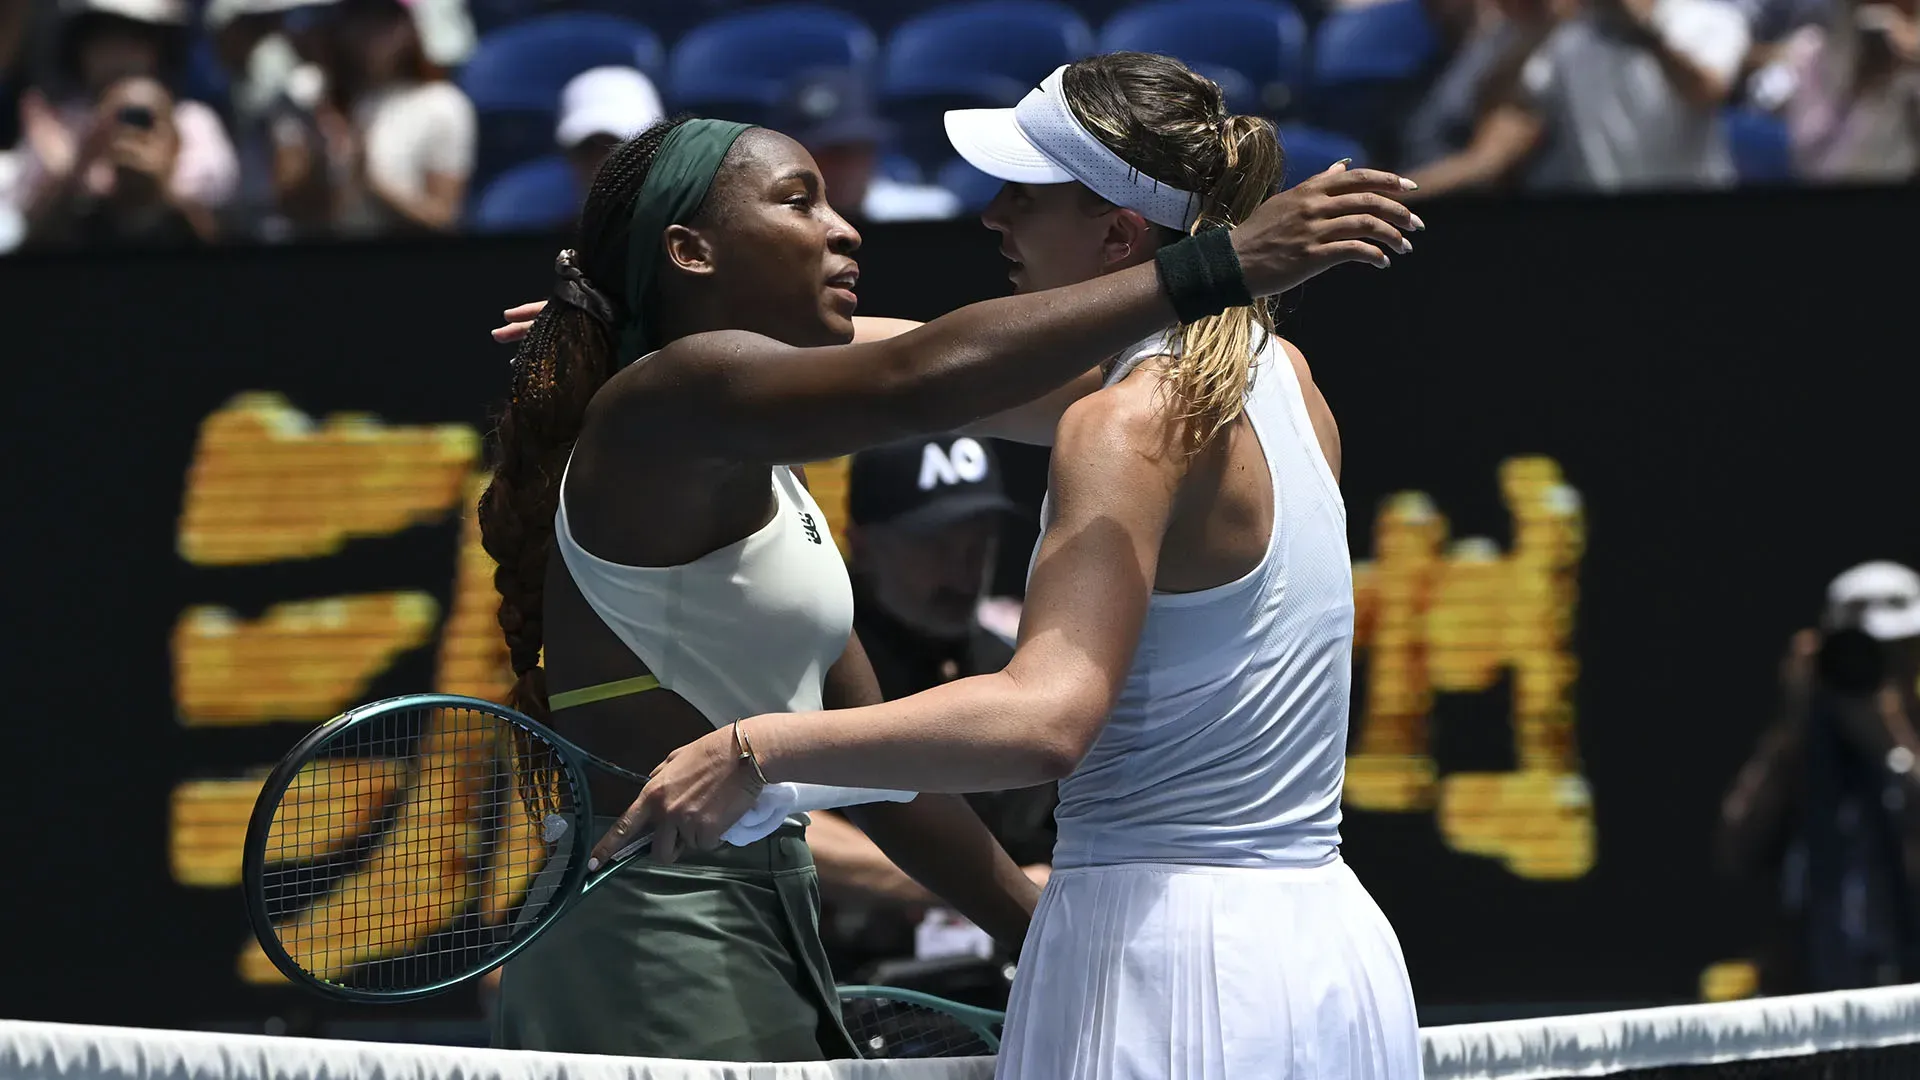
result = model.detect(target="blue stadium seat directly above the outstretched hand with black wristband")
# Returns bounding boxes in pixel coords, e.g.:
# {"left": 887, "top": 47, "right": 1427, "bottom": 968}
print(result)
{"left": 1308, "top": 0, "right": 1440, "bottom": 161}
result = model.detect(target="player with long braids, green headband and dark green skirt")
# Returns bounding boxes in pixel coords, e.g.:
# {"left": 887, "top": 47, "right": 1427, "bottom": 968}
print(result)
{"left": 480, "top": 73, "right": 1409, "bottom": 1061}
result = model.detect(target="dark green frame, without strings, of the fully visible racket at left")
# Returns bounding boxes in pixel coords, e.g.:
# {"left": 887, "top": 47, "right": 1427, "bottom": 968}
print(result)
{"left": 240, "top": 694, "right": 649, "bottom": 1003}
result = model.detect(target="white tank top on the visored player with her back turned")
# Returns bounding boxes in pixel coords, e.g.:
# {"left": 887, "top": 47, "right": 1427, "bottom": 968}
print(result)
{"left": 1041, "top": 332, "right": 1354, "bottom": 867}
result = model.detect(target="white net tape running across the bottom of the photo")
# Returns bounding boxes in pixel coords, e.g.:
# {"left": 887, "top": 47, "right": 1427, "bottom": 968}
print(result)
{"left": 0, "top": 986, "right": 1920, "bottom": 1080}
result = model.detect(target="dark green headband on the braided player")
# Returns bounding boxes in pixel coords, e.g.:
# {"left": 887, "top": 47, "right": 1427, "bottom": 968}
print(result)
{"left": 620, "top": 119, "right": 753, "bottom": 363}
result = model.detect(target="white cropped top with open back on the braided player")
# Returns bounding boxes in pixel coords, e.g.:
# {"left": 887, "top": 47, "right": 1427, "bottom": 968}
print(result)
{"left": 553, "top": 457, "right": 852, "bottom": 728}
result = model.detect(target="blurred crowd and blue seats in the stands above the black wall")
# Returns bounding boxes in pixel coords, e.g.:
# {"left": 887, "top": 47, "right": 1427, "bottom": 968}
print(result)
{"left": 0, "top": 0, "right": 1920, "bottom": 250}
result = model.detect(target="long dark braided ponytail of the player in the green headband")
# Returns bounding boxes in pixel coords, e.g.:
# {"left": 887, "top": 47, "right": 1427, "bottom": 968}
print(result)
{"left": 480, "top": 121, "right": 698, "bottom": 721}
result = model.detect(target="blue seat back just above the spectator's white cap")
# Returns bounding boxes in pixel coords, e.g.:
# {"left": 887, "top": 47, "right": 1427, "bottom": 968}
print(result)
{"left": 461, "top": 12, "right": 662, "bottom": 111}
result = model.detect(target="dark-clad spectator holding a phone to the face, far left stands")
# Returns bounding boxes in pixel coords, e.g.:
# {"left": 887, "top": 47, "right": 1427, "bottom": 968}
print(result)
{"left": 27, "top": 77, "right": 213, "bottom": 248}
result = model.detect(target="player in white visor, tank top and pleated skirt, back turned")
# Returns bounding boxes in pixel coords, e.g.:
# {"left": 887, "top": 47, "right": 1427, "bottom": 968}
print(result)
{"left": 595, "top": 54, "right": 1421, "bottom": 1080}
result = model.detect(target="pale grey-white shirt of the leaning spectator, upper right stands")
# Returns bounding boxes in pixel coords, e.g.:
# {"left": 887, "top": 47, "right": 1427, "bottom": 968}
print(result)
{"left": 1521, "top": 0, "right": 1749, "bottom": 190}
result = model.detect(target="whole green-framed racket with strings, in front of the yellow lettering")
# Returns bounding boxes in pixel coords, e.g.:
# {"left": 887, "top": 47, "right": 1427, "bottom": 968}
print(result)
{"left": 242, "top": 694, "right": 651, "bottom": 1001}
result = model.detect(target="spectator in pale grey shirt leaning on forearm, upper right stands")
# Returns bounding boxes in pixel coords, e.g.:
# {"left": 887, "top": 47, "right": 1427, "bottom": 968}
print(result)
{"left": 1411, "top": 0, "right": 1749, "bottom": 198}
